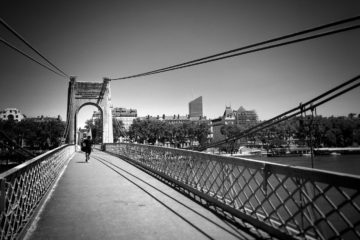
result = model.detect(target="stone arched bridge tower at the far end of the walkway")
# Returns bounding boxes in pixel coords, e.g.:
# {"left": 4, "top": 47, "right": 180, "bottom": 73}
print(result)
{"left": 67, "top": 77, "right": 114, "bottom": 144}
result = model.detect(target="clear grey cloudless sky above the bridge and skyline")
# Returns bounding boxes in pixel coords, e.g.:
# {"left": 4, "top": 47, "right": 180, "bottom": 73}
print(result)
{"left": 0, "top": 0, "right": 360, "bottom": 125}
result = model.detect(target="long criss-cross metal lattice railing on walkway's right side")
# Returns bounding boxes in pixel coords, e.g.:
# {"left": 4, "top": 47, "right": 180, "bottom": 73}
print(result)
{"left": 105, "top": 143, "right": 360, "bottom": 239}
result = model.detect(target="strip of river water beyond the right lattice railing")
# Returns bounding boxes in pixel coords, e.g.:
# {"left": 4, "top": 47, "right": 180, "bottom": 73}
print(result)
{"left": 240, "top": 154, "right": 360, "bottom": 176}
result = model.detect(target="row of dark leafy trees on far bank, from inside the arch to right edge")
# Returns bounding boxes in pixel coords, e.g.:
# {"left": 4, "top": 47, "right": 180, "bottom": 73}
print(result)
{"left": 83, "top": 113, "right": 360, "bottom": 148}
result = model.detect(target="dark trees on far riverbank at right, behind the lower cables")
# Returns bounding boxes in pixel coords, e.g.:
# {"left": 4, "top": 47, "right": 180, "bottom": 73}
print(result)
{"left": 221, "top": 114, "right": 360, "bottom": 147}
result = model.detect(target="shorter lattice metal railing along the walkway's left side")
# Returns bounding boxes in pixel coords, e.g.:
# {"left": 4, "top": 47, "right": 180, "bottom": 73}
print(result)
{"left": 0, "top": 145, "right": 75, "bottom": 240}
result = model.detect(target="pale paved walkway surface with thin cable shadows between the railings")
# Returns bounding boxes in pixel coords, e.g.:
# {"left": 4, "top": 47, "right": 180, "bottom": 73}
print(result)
{"left": 25, "top": 151, "right": 251, "bottom": 240}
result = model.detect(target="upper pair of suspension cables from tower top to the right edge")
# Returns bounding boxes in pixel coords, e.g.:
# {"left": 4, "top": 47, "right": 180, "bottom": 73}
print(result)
{"left": 111, "top": 16, "right": 360, "bottom": 80}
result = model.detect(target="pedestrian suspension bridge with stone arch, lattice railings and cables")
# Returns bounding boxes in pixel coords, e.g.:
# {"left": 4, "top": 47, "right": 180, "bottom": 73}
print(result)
{"left": 0, "top": 17, "right": 360, "bottom": 239}
